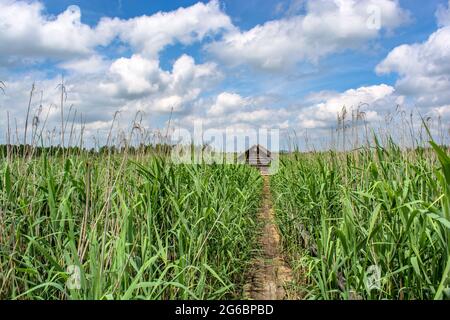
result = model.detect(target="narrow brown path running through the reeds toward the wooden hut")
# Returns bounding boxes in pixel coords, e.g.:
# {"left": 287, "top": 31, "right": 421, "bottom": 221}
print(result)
{"left": 244, "top": 175, "right": 292, "bottom": 300}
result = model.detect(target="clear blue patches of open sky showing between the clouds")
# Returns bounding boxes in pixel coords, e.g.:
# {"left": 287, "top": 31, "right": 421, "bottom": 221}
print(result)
{"left": 26, "top": 0, "right": 445, "bottom": 92}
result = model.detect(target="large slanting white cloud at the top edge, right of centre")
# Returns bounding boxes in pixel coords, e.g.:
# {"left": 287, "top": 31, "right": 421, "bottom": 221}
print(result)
{"left": 208, "top": 0, "right": 409, "bottom": 70}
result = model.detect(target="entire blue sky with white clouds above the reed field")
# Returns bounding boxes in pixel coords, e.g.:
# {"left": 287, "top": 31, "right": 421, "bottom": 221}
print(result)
{"left": 0, "top": 0, "right": 450, "bottom": 149}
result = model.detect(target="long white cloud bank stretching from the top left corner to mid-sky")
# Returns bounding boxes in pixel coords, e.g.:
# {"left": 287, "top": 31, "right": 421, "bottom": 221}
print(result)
{"left": 0, "top": 0, "right": 233, "bottom": 63}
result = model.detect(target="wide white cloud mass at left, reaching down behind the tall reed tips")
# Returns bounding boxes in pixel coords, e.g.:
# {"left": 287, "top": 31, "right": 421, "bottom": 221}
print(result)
{"left": 0, "top": 55, "right": 222, "bottom": 146}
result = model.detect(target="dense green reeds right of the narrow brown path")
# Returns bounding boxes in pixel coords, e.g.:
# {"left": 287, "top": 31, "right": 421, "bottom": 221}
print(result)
{"left": 272, "top": 141, "right": 450, "bottom": 299}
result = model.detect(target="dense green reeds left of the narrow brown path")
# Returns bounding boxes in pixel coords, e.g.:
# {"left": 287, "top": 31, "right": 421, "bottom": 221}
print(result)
{"left": 0, "top": 150, "right": 262, "bottom": 299}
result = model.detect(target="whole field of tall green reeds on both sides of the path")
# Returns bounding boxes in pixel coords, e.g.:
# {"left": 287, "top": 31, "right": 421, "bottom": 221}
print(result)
{"left": 0, "top": 95, "right": 450, "bottom": 300}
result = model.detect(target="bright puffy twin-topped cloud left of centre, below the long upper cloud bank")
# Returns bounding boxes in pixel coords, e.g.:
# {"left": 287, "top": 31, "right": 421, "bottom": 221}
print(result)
{"left": 99, "top": 54, "right": 221, "bottom": 112}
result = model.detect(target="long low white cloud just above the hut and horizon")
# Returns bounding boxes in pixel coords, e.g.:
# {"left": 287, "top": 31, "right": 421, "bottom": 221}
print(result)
{"left": 178, "top": 84, "right": 403, "bottom": 138}
